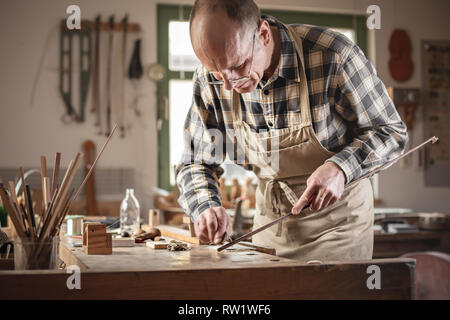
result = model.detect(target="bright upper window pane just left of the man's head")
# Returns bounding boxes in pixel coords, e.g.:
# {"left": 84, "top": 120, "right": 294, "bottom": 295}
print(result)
{"left": 169, "top": 21, "right": 200, "bottom": 71}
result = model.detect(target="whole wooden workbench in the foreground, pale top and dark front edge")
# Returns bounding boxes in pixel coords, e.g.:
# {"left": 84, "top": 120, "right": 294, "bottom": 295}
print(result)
{"left": 0, "top": 235, "right": 415, "bottom": 300}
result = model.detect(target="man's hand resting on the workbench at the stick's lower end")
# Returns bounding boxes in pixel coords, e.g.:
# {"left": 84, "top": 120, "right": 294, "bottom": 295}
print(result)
{"left": 194, "top": 207, "right": 231, "bottom": 244}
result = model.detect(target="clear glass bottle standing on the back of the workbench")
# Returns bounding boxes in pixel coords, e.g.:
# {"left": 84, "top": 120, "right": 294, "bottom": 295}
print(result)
{"left": 120, "top": 189, "right": 140, "bottom": 235}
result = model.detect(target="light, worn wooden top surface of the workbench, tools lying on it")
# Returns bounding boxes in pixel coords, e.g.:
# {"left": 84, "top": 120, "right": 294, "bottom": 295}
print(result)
{"left": 60, "top": 241, "right": 298, "bottom": 271}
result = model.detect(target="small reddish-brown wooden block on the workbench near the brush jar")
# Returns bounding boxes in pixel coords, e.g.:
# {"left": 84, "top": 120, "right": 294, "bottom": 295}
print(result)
{"left": 83, "top": 222, "right": 112, "bottom": 254}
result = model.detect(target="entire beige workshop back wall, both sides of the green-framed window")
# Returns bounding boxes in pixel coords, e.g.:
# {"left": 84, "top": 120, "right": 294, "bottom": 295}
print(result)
{"left": 0, "top": 0, "right": 450, "bottom": 212}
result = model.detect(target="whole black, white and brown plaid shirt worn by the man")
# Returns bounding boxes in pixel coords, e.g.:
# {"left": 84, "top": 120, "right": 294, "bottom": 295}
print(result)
{"left": 176, "top": 16, "right": 408, "bottom": 221}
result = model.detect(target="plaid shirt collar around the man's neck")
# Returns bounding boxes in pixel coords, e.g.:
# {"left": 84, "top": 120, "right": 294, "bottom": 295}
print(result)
{"left": 261, "top": 15, "right": 300, "bottom": 82}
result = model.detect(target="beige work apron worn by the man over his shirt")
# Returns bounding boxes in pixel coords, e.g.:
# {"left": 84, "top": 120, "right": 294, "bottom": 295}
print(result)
{"left": 233, "top": 26, "right": 374, "bottom": 261}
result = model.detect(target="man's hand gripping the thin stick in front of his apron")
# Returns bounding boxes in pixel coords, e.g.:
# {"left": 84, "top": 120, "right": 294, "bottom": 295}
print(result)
{"left": 292, "top": 162, "right": 345, "bottom": 214}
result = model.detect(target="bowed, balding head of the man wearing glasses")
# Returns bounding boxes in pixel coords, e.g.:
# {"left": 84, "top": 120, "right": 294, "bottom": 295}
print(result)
{"left": 190, "top": 0, "right": 274, "bottom": 93}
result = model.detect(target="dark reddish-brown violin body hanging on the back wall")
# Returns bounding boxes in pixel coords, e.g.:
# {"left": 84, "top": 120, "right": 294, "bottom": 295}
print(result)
{"left": 389, "top": 29, "right": 414, "bottom": 81}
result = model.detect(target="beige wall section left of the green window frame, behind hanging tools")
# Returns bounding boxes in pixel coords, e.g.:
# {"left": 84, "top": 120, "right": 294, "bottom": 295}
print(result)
{"left": 0, "top": 0, "right": 157, "bottom": 212}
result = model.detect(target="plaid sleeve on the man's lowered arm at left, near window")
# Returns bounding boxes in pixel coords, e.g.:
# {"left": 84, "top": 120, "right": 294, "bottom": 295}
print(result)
{"left": 176, "top": 72, "right": 225, "bottom": 221}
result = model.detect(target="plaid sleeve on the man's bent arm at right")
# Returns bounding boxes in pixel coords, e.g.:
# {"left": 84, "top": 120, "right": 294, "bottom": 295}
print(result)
{"left": 327, "top": 46, "right": 408, "bottom": 183}
